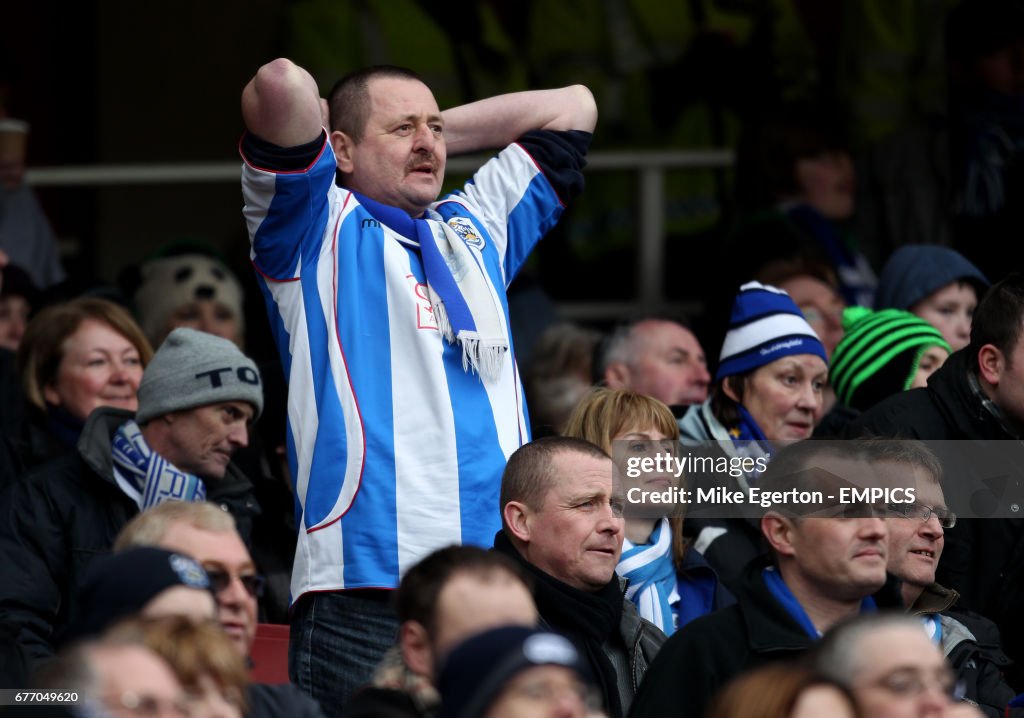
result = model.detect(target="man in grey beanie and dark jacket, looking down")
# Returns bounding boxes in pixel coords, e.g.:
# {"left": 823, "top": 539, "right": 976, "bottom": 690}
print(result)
{"left": 0, "top": 329, "right": 263, "bottom": 662}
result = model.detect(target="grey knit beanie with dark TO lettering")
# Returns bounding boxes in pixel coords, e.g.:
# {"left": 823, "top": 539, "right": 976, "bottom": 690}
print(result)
{"left": 135, "top": 328, "right": 263, "bottom": 424}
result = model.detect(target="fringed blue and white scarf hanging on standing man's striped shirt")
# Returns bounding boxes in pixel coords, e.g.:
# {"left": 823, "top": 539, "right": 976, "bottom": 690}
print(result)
{"left": 352, "top": 192, "right": 509, "bottom": 382}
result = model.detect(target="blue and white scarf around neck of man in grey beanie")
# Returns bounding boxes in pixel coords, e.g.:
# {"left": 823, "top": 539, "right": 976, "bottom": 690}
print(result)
{"left": 111, "top": 419, "right": 206, "bottom": 511}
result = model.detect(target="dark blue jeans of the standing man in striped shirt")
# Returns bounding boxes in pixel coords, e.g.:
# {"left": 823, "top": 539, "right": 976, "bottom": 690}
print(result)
{"left": 288, "top": 591, "right": 398, "bottom": 718}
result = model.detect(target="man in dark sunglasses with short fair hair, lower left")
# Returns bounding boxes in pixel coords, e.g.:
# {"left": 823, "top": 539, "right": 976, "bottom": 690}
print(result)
{"left": 114, "top": 497, "right": 323, "bottom": 718}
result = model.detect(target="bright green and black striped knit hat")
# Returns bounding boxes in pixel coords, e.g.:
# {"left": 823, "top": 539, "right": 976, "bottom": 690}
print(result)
{"left": 829, "top": 306, "right": 952, "bottom": 411}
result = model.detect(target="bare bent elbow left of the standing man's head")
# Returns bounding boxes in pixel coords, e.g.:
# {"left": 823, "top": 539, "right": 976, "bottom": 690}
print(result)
{"left": 242, "top": 57, "right": 325, "bottom": 147}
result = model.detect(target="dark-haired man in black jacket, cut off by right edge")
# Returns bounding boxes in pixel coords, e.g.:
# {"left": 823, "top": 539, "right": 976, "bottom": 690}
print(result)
{"left": 851, "top": 273, "right": 1024, "bottom": 691}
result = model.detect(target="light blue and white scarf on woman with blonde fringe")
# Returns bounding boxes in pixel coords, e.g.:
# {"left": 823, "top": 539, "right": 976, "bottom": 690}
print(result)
{"left": 615, "top": 518, "right": 679, "bottom": 636}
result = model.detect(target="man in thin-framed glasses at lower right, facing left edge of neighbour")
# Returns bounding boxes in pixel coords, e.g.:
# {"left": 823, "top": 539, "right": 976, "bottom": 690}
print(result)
{"left": 865, "top": 440, "right": 1015, "bottom": 718}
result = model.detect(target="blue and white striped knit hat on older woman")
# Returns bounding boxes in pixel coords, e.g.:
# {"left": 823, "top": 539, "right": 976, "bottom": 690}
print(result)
{"left": 715, "top": 282, "right": 828, "bottom": 381}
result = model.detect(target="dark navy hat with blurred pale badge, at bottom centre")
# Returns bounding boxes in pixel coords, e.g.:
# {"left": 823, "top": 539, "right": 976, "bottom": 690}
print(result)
{"left": 437, "top": 626, "right": 591, "bottom": 718}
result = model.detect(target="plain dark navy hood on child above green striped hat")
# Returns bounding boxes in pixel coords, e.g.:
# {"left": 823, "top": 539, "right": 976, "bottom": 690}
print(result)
{"left": 874, "top": 245, "right": 991, "bottom": 309}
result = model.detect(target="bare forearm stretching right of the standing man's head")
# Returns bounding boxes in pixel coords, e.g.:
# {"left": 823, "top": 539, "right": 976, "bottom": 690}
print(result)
{"left": 441, "top": 85, "right": 597, "bottom": 155}
